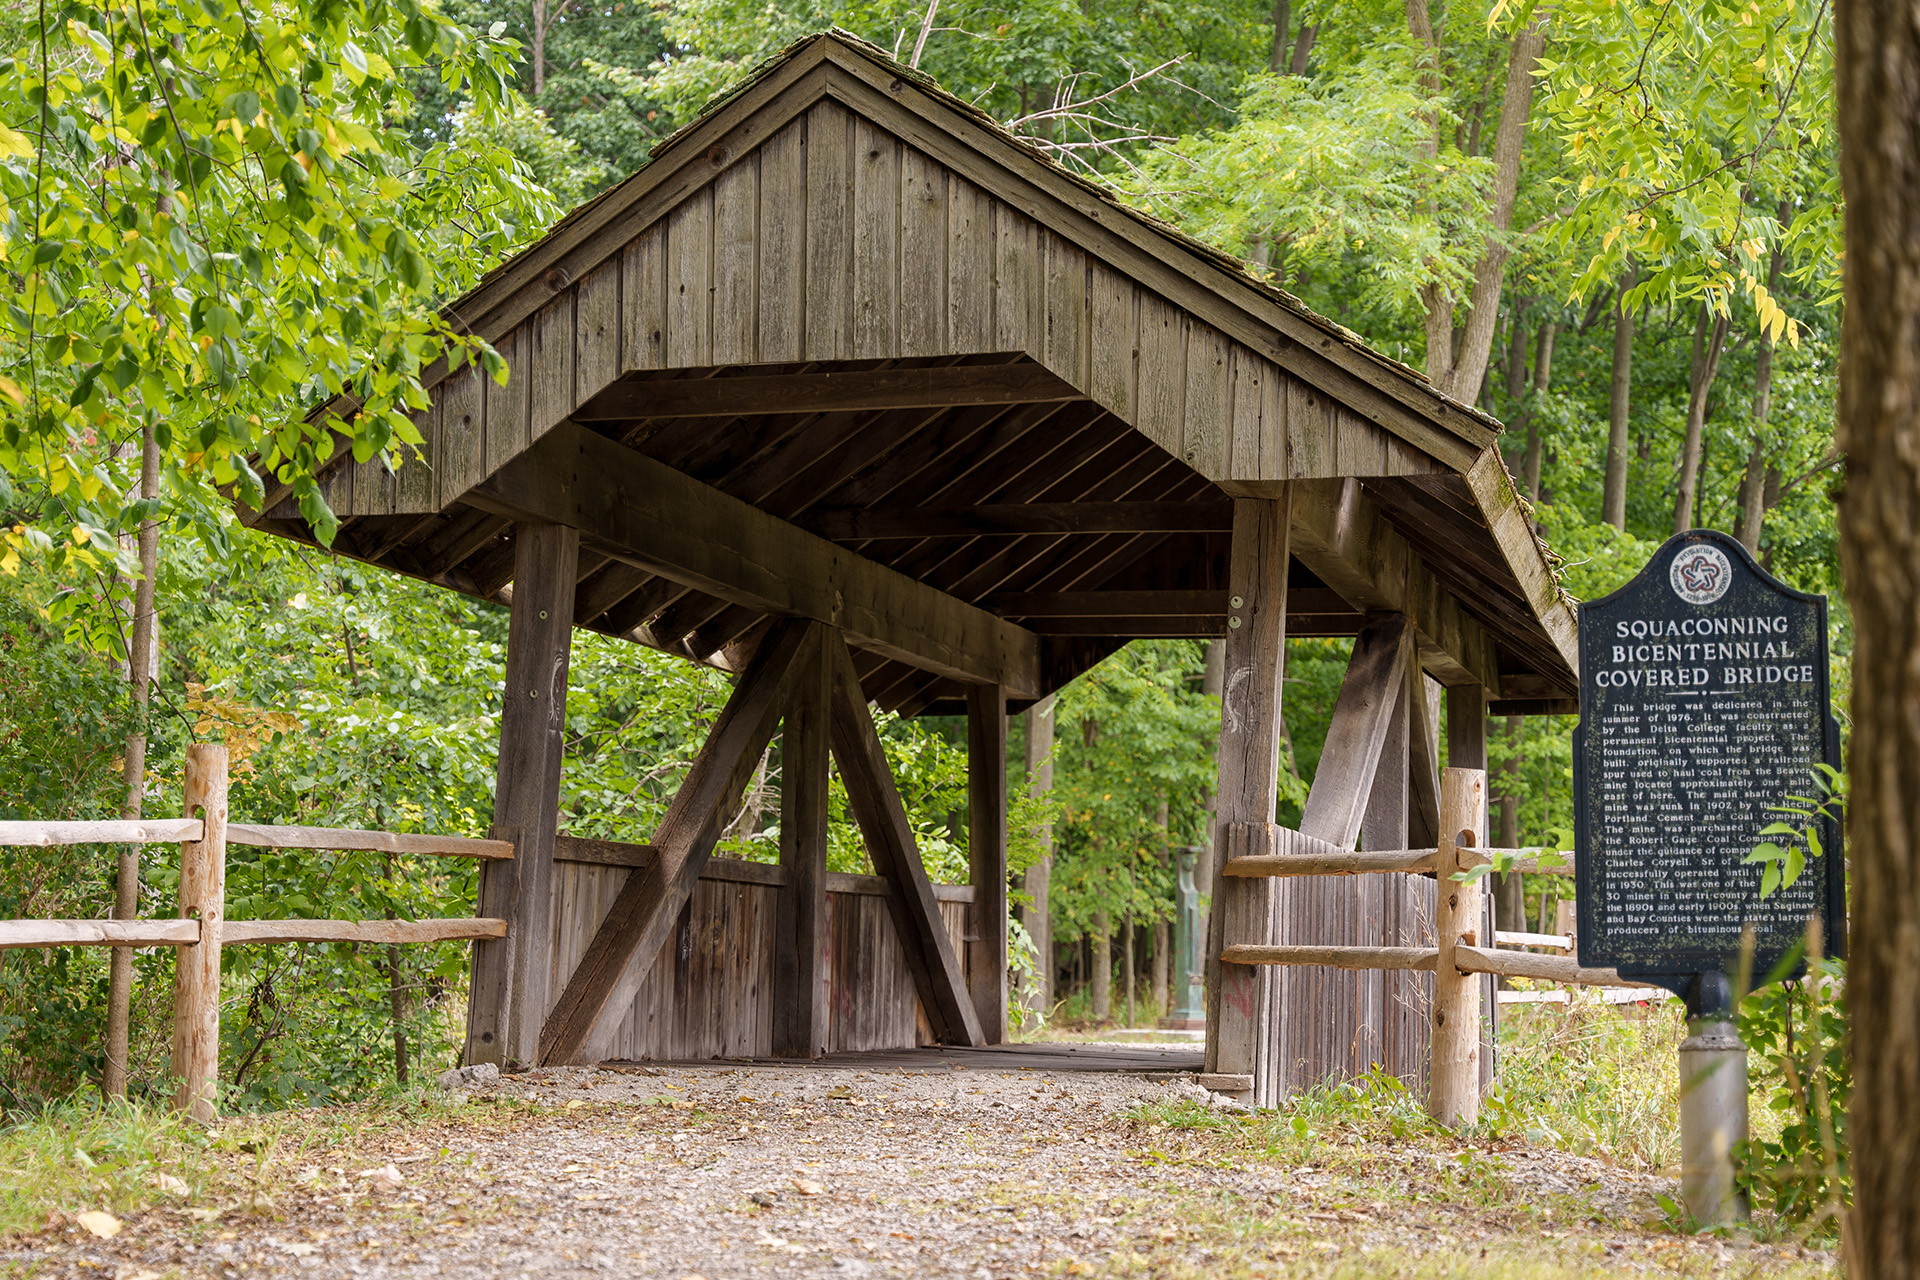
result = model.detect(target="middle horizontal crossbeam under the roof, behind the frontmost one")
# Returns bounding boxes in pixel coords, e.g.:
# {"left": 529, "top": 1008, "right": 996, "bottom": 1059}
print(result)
{"left": 806, "top": 501, "right": 1233, "bottom": 541}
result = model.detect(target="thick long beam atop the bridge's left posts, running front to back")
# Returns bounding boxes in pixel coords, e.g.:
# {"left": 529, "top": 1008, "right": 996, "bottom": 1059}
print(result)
{"left": 465, "top": 422, "right": 1046, "bottom": 699}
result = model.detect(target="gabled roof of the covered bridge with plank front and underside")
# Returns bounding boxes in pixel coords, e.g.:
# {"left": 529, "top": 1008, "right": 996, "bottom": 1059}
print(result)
{"left": 247, "top": 33, "right": 1576, "bottom": 710}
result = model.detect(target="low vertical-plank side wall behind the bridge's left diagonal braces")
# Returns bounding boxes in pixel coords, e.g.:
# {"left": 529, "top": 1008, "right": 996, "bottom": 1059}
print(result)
{"left": 551, "top": 862, "right": 966, "bottom": 1059}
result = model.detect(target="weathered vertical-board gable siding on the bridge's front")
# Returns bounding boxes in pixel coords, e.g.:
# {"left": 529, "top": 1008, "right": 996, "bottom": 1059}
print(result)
{"left": 357, "top": 100, "right": 1444, "bottom": 514}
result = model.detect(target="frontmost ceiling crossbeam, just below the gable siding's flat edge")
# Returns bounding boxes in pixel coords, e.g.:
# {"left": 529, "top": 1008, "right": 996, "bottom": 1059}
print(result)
{"left": 572, "top": 363, "right": 1087, "bottom": 422}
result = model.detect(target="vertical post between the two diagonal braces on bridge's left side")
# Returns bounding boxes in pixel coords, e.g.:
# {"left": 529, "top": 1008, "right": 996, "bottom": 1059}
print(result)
{"left": 774, "top": 635, "right": 833, "bottom": 1057}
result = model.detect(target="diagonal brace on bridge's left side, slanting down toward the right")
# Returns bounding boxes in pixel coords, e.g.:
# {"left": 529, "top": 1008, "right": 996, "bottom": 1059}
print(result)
{"left": 828, "top": 637, "right": 983, "bottom": 1046}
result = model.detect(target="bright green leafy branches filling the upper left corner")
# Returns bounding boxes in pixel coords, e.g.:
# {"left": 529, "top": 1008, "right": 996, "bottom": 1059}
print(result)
{"left": 0, "top": 0, "right": 555, "bottom": 587}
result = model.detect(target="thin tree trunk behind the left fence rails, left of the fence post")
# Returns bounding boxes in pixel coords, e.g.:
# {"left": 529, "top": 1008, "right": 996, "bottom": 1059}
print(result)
{"left": 100, "top": 422, "right": 159, "bottom": 1098}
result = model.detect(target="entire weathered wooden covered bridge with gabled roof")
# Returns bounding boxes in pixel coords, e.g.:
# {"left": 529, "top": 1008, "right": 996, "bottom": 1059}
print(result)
{"left": 246, "top": 35, "right": 1576, "bottom": 1100}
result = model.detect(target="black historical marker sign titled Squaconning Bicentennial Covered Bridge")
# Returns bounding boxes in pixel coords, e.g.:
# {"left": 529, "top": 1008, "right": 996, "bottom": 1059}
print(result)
{"left": 1572, "top": 530, "right": 1845, "bottom": 975}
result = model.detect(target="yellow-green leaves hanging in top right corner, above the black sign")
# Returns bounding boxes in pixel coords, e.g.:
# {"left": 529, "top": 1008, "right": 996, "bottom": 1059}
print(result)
{"left": 1542, "top": 0, "right": 1839, "bottom": 318}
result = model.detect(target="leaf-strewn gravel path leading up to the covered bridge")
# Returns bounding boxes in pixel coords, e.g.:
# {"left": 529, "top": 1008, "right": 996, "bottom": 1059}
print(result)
{"left": 18, "top": 1069, "right": 1828, "bottom": 1280}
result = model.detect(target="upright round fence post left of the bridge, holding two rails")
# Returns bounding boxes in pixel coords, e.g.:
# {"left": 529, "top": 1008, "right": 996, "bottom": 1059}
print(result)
{"left": 173, "top": 743, "right": 227, "bottom": 1123}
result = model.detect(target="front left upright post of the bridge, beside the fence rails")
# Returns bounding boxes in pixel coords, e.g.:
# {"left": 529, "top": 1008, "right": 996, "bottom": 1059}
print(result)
{"left": 467, "top": 524, "right": 580, "bottom": 1067}
